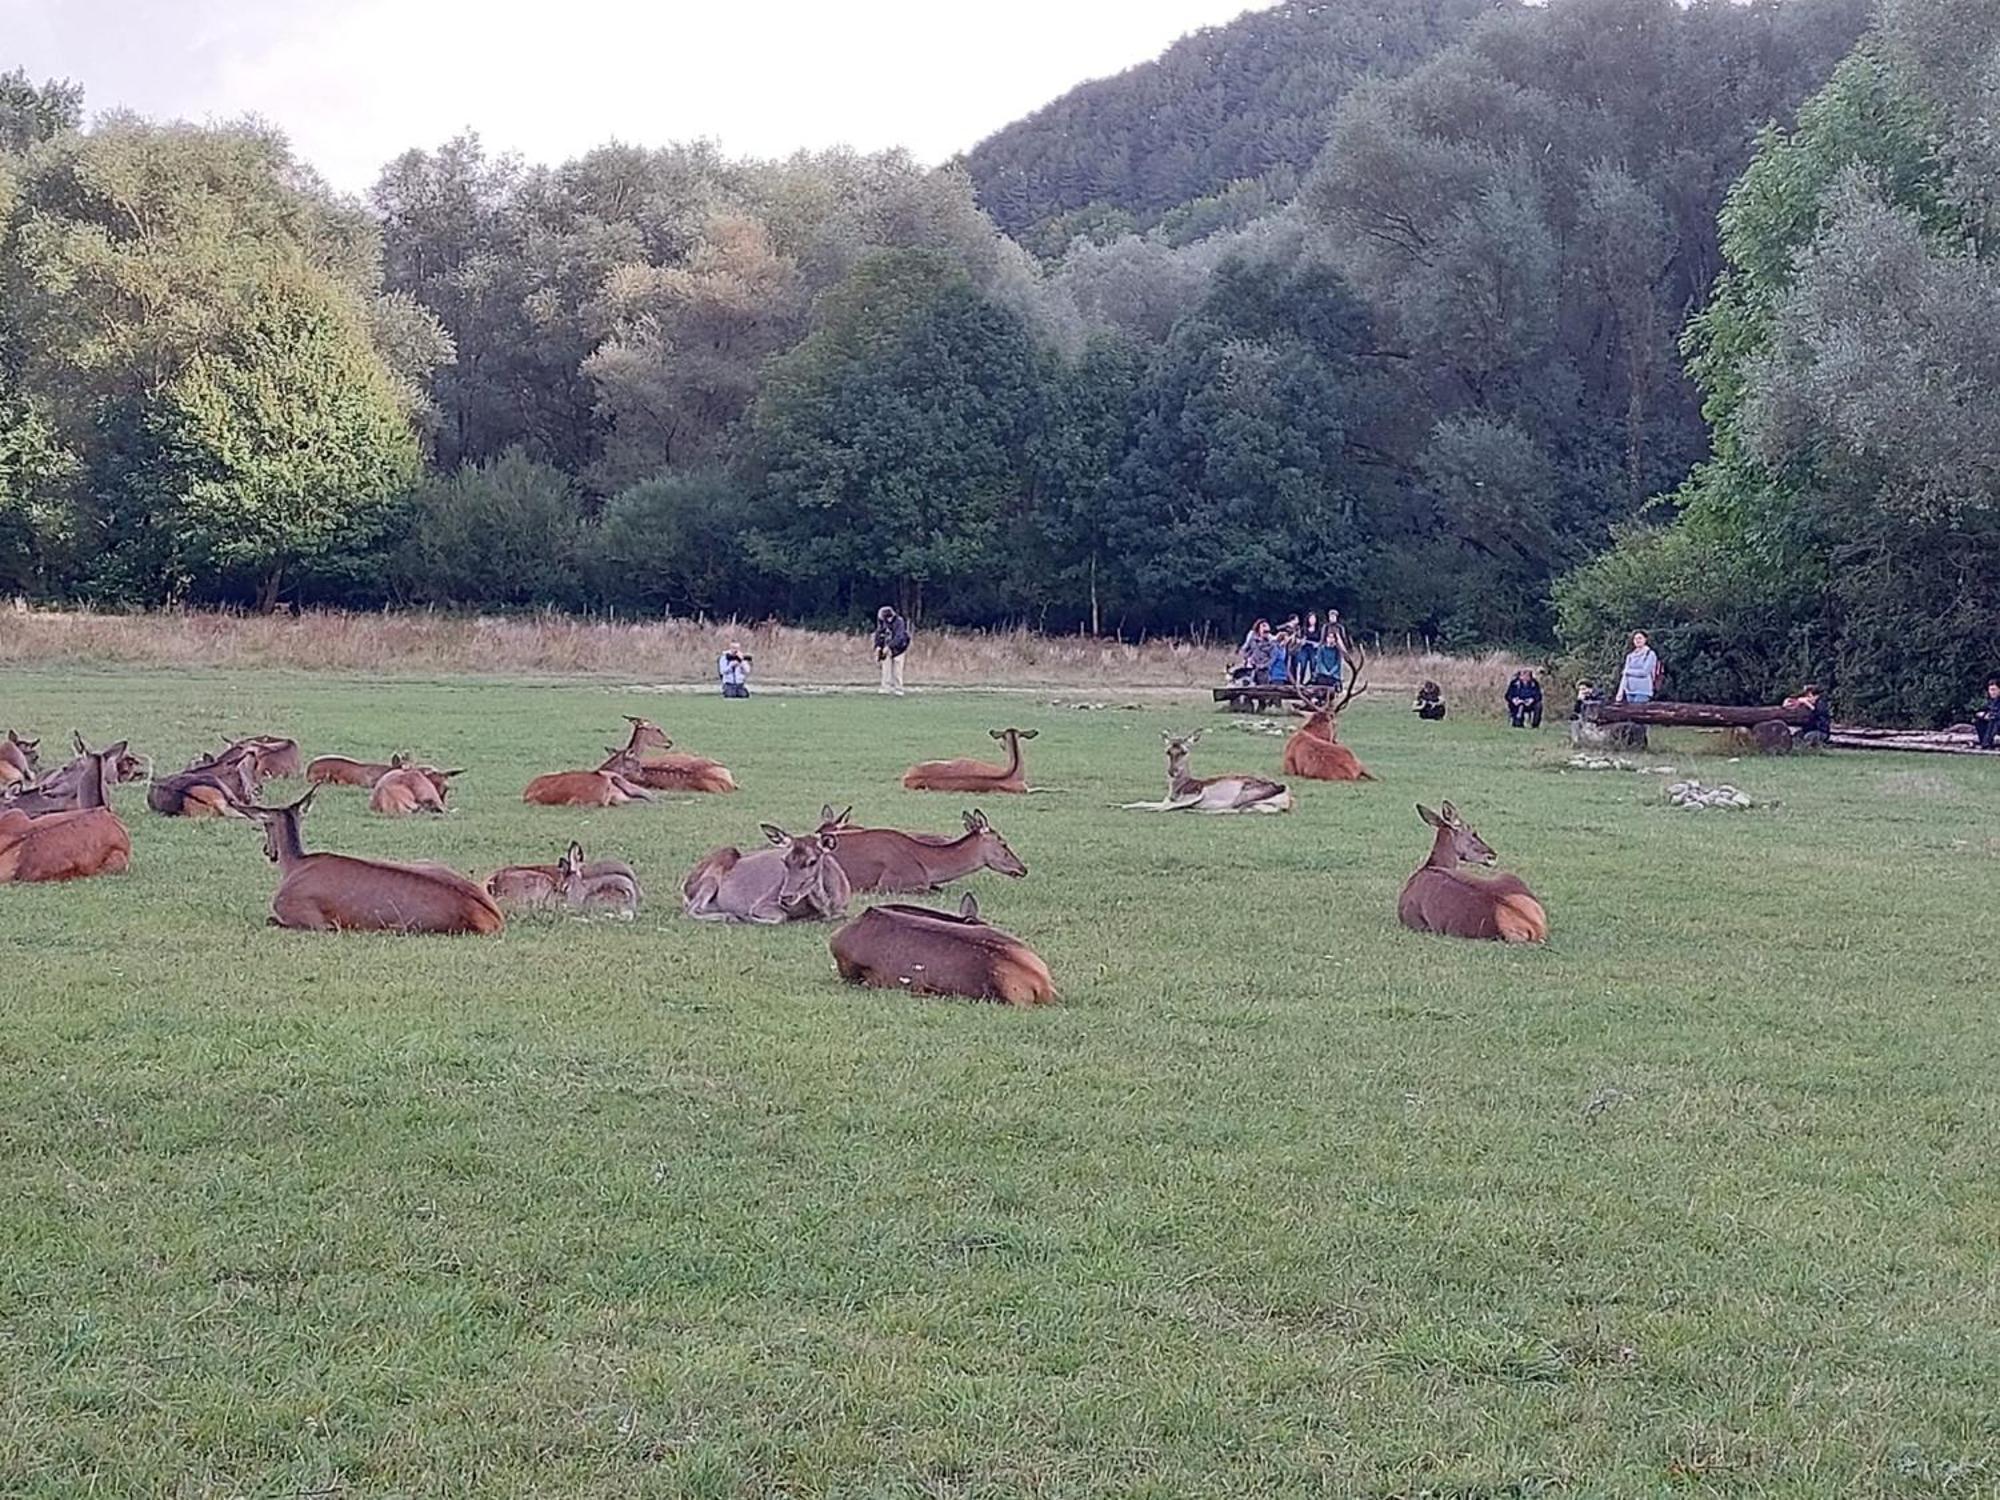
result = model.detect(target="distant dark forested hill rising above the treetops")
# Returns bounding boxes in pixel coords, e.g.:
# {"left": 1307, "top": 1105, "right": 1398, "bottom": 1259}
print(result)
{"left": 966, "top": 0, "right": 1516, "bottom": 252}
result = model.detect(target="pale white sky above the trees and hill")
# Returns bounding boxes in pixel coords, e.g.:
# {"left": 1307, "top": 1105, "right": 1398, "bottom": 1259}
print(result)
{"left": 0, "top": 0, "right": 1270, "bottom": 192}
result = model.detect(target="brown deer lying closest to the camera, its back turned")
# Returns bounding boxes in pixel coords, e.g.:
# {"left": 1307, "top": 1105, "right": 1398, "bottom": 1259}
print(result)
{"left": 826, "top": 894, "right": 1056, "bottom": 1006}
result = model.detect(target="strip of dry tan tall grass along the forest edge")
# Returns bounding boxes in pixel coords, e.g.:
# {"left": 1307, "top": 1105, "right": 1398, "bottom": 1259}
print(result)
{"left": 0, "top": 608, "right": 1516, "bottom": 712}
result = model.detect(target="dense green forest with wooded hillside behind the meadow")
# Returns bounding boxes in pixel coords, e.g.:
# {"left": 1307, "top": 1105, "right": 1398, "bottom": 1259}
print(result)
{"left": 0, "top": 0, "right": 2000, "bottom": 718}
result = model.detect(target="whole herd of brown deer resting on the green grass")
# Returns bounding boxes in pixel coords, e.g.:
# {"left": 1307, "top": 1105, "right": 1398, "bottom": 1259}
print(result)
{"left": 0, "top": 658, "right": 1548, "bottom": 1004}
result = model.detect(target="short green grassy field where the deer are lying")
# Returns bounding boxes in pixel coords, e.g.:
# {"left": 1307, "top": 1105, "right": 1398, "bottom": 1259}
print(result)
{"left": 0, "top": 670, "right": 2000, "bottom": 1500}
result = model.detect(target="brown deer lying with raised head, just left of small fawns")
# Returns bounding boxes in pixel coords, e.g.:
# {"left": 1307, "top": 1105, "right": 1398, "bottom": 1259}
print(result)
{"left": 246, "top": 786, "right": 506, "bottom": 934}
